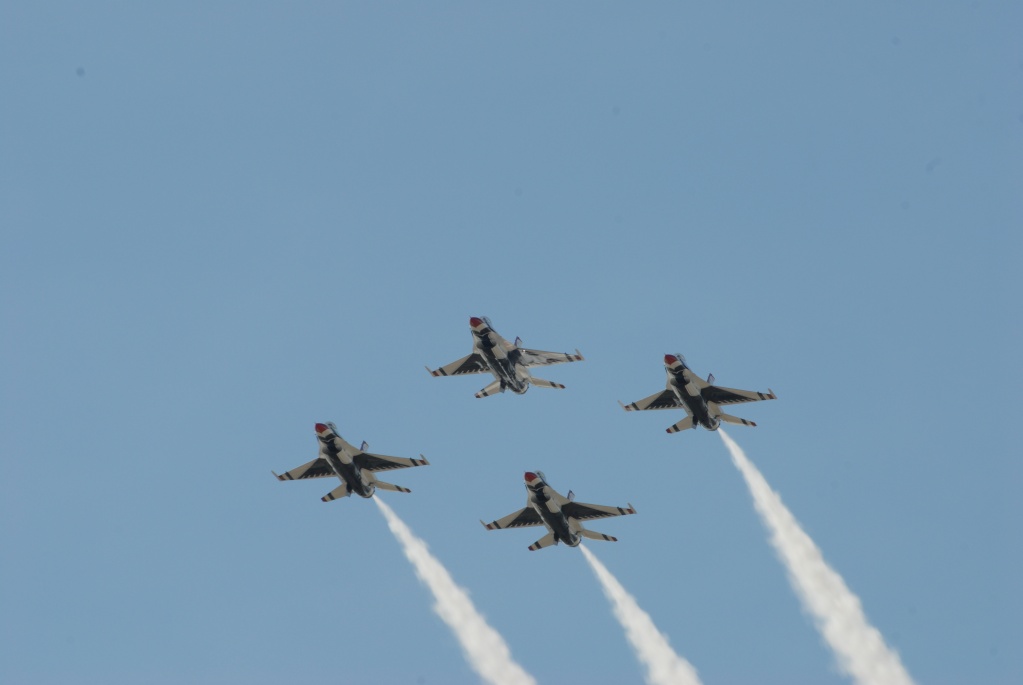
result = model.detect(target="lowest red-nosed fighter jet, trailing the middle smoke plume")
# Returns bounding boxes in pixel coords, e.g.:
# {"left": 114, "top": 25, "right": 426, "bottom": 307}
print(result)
{"left": 480, "top": 471, "right": 636, "bottom": 552}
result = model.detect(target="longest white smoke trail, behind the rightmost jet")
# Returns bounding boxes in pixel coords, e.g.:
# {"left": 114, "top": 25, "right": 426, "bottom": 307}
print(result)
{"left": 718, "top": 428, "right": 914, "bottom": 685}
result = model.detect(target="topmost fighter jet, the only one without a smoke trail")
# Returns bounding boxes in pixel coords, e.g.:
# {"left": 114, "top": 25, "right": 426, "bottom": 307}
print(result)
{"left": 427, "top": 316, "right": 583, "bottom": 398}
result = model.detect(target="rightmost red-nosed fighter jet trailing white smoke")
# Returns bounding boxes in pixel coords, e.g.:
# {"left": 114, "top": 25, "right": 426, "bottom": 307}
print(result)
{"left": 618, "top": 355, "right": 777, "bottom": 432}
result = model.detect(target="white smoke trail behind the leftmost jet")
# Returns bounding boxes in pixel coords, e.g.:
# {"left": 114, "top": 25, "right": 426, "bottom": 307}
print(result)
{"left": 372, "top": 497, "right": 536, "bottom": 685}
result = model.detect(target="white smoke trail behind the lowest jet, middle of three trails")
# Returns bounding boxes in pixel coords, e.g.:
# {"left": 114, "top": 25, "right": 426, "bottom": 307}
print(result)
{"left": 579, "top": 545, "right": 700, "bottom": 685}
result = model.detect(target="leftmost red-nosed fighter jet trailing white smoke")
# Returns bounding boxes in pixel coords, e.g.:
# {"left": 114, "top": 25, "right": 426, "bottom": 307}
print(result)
{"left": 271, "top": 422, "right": 430, "bottom": 502}
